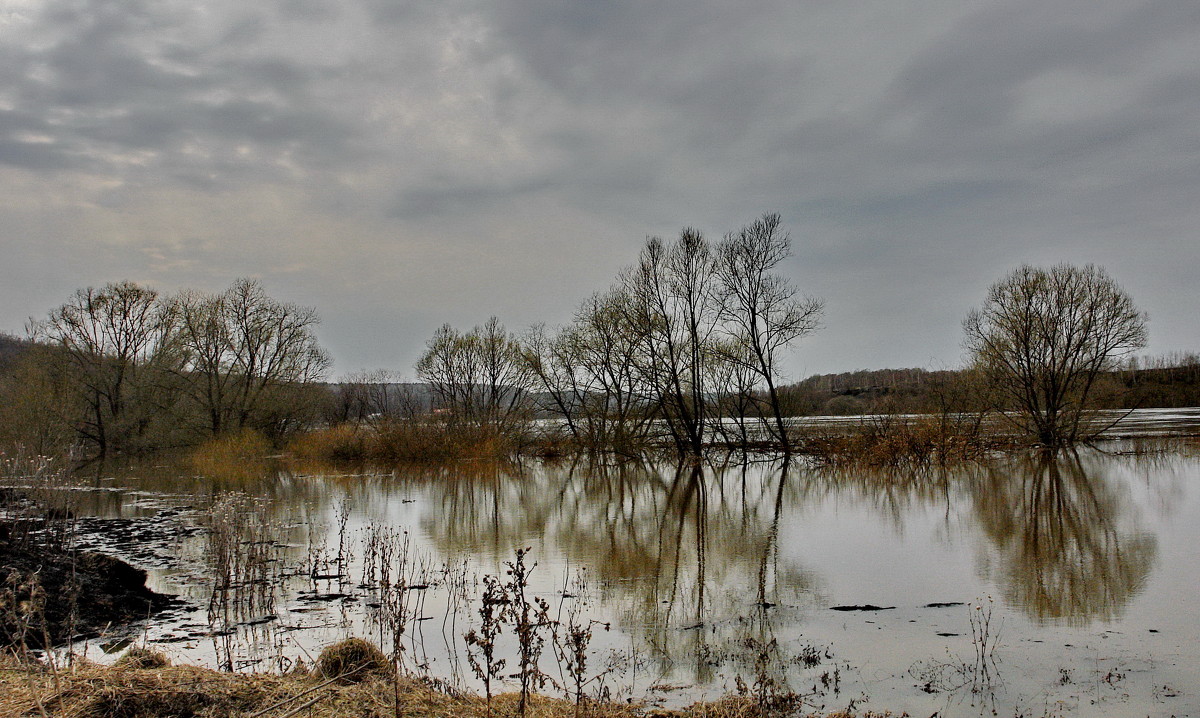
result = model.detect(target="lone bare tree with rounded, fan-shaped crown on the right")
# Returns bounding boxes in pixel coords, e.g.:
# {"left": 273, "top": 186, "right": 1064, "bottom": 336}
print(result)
{"left": 962, "top": 264, "right": 1146, "bottom": 447}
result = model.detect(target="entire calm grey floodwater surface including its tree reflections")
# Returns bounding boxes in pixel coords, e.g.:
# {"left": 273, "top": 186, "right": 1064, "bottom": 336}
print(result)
{"left": 25, "top": 415, "right": 1200, "bottom": 716}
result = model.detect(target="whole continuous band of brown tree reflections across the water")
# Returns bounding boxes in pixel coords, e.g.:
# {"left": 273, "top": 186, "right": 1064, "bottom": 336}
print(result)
{"left": 70, "top": 450, "right": 1166, "bottom": 638}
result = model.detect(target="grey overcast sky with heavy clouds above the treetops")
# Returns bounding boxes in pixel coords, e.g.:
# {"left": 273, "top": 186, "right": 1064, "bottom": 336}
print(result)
{"left": 0, "top": 0, "right": 1200, "bottom": 377}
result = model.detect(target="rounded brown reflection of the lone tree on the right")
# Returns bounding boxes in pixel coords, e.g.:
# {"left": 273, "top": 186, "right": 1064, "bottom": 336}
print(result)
{"left": 974, "top": 450, "right": 1157, "bottom": 626}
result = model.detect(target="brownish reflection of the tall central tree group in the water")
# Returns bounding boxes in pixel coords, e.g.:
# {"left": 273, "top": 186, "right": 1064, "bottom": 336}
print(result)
{"left": 412, "top": 461, "right": 815, "bottom": 683}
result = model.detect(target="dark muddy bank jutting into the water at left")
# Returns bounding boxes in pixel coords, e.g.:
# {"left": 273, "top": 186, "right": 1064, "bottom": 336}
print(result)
{"left": 0, "top": 492, "right": 176, "bottom": 648}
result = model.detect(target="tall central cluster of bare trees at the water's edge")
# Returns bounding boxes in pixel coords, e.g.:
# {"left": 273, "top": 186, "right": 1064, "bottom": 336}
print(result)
{"left": 527, "top": 215, "right": 822, "bottom": 455}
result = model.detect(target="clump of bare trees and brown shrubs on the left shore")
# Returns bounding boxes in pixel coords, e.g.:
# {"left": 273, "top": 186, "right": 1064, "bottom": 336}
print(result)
{"left": 0, "top": 280, "right": 329, "bottom": 456}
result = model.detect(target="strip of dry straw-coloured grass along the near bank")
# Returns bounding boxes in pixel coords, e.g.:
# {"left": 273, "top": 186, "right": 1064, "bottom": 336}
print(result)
{"left": 0, "top": 659, "right": 892, "bottom": 718}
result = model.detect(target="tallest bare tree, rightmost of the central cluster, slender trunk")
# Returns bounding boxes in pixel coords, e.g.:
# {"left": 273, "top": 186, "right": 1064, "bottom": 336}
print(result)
{"left": 716, "top": 214, "right": 824, "bottom": 451}
